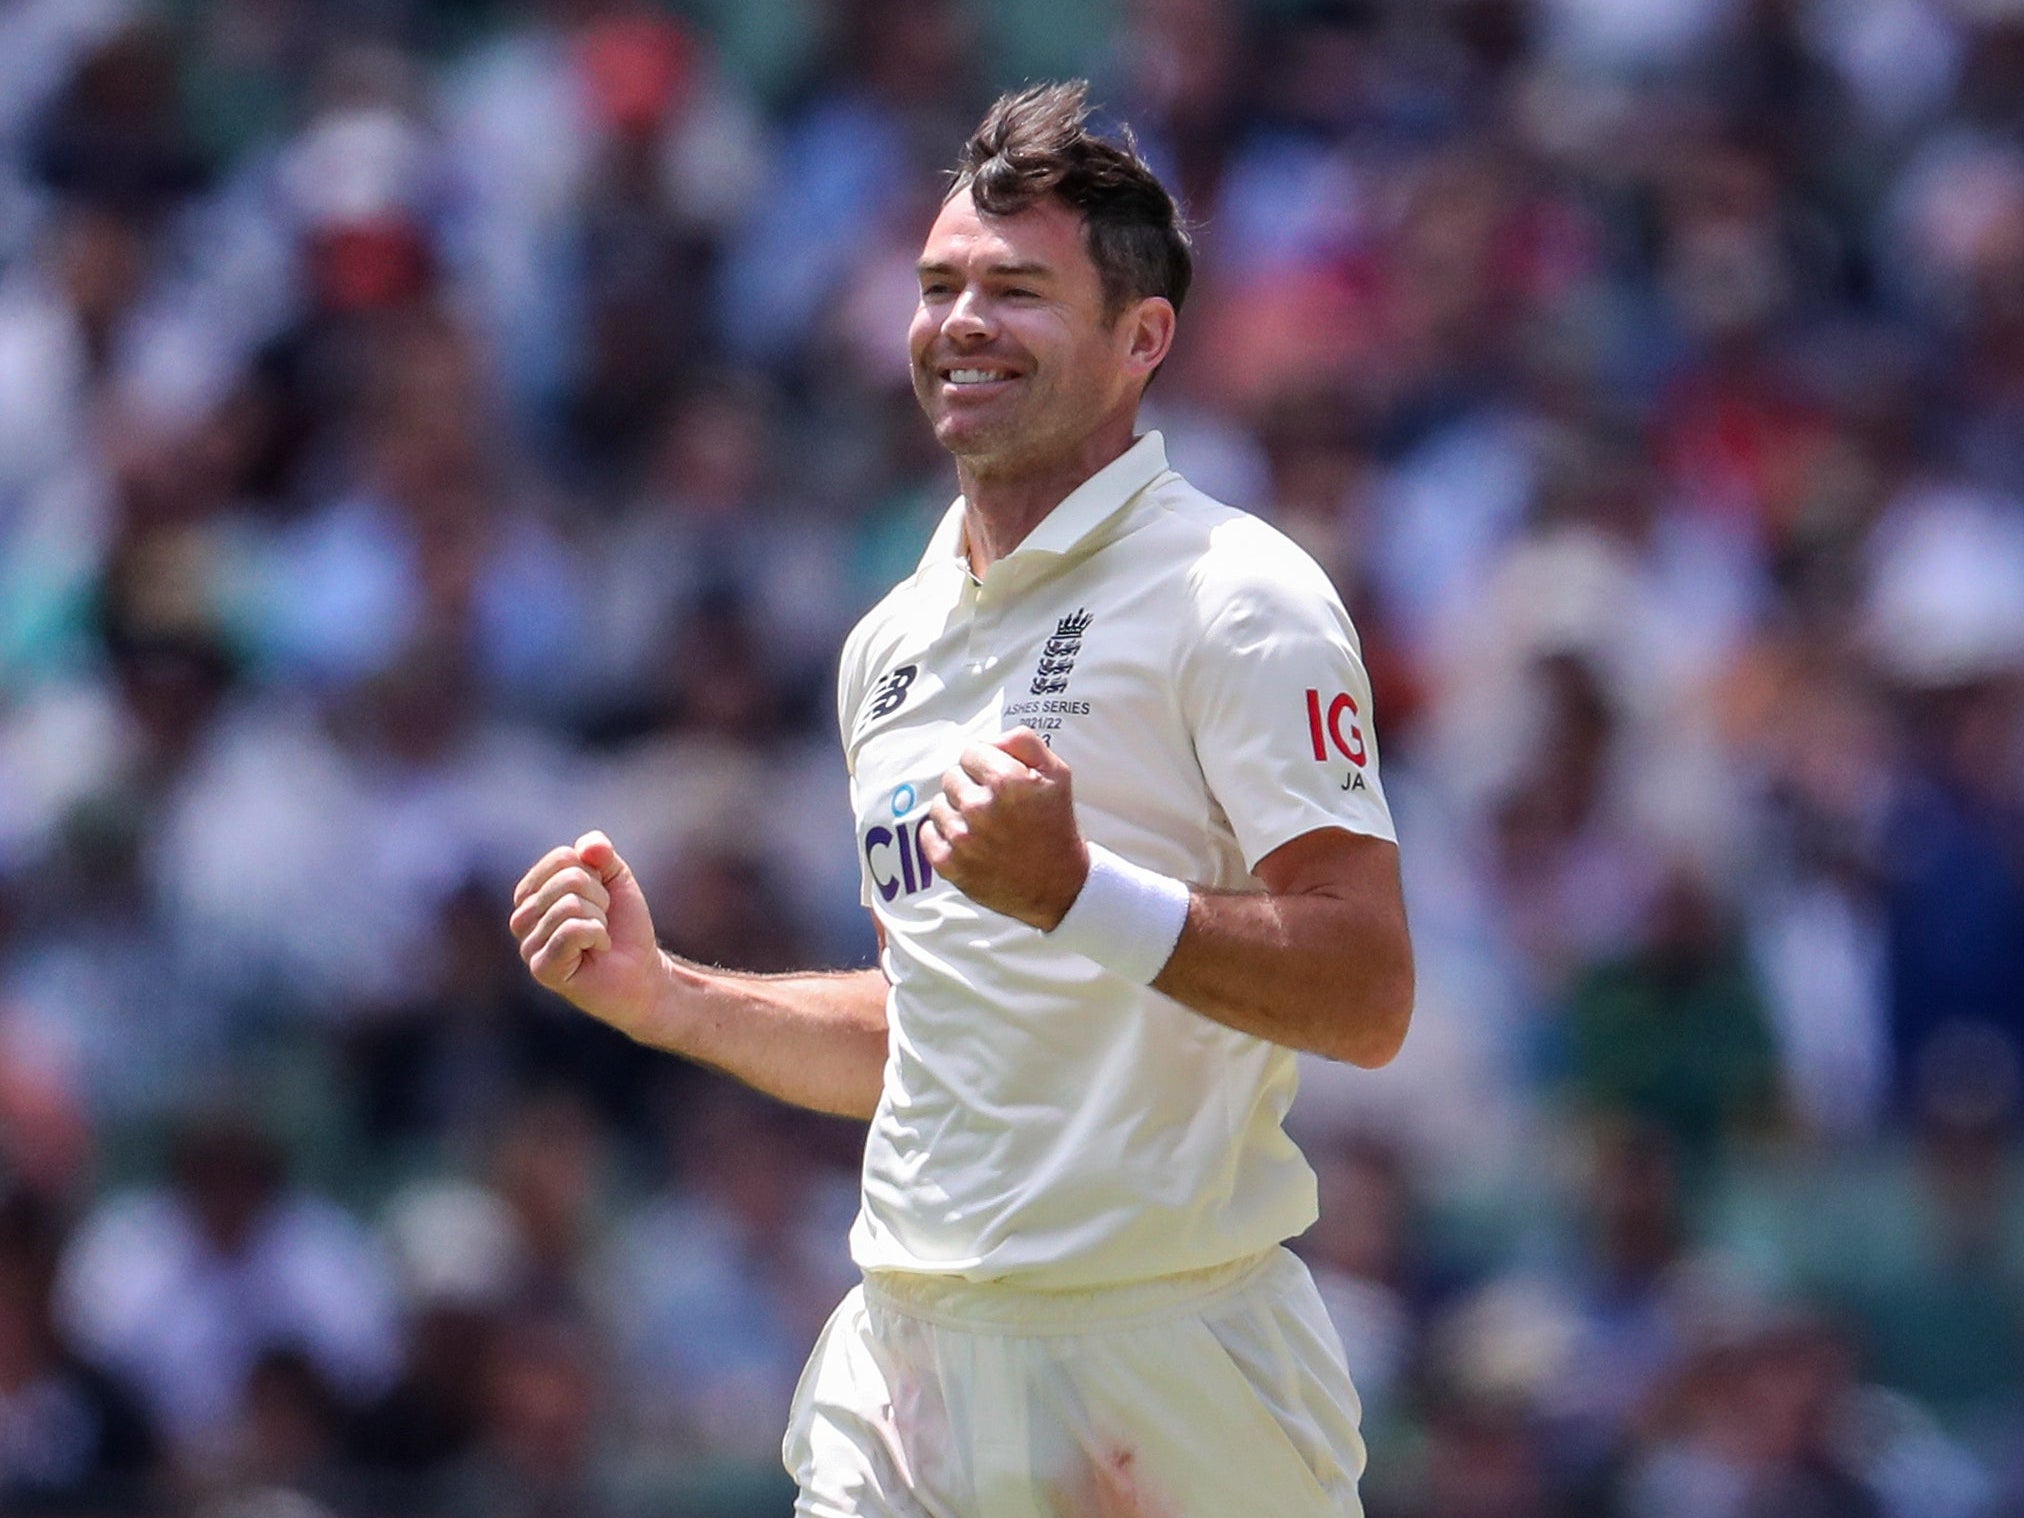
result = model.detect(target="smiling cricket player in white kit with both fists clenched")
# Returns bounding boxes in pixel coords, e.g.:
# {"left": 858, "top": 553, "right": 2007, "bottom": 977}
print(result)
{"left": 512, "top": 85, "right": 1413, "bottom": 1518}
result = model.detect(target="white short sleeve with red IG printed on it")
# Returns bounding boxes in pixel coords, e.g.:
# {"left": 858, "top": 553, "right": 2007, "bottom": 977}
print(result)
{"left": 1180, "top": 542, "right": 1397, "bottom": 868}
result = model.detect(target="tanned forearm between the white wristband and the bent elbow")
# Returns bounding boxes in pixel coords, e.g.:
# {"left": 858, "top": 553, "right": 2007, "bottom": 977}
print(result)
{"left": 1154, "top": 887, "right": 1413, "bottom": 1069}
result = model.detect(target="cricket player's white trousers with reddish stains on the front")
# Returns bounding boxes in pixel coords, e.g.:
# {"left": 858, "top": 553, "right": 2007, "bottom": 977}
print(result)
{"left": 781, "top": 1249, "right": 1364, "bottom": 1518}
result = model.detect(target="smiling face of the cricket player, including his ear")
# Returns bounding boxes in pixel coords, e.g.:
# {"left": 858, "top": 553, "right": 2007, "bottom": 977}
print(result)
{"left": 907, "top": 190, "right": 1174, "bottom": 478}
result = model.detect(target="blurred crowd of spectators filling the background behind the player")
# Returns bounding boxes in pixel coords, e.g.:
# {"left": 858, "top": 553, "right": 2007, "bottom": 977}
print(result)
{"left": 0, "top": 0, "right": 2024, "bottom": 1518}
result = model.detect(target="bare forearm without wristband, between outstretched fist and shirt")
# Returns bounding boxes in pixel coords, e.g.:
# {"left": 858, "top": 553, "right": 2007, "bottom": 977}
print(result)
{"left": 634, "top": 953, "right": 887, "bottom": 1119}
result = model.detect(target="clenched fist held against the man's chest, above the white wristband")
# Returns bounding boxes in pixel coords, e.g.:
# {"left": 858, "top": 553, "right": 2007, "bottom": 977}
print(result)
{"left": 921, "top": 727, "right": 1089, "bottom": 933}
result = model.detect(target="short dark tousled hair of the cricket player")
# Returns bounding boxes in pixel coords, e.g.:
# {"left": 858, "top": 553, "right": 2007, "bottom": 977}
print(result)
{"left": 945, "top": 79, "right": 1194, "bottom": 316}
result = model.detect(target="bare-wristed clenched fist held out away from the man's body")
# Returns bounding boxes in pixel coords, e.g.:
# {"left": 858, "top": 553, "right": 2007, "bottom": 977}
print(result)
{"left": 508, "top": 832, "right": 664, "bottom": 1038}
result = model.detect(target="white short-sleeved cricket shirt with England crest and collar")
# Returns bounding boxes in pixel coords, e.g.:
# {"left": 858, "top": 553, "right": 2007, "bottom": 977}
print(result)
{"left": 838, "top": 433, "right": 1395, "bottom": 1287}
